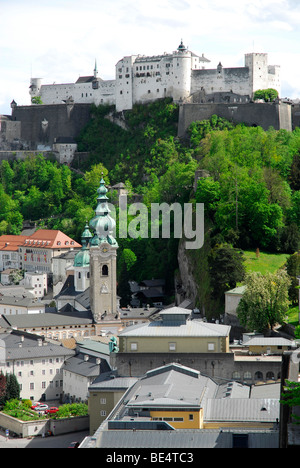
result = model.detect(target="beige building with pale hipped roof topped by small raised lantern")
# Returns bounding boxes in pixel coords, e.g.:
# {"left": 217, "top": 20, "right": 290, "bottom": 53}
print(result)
{"left": 119, "top": 307, "right": 230, "bottom": 353}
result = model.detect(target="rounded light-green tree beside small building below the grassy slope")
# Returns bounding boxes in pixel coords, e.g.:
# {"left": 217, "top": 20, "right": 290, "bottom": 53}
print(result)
{"left": 237, "top": 270, "right": 290, "bottom": 331}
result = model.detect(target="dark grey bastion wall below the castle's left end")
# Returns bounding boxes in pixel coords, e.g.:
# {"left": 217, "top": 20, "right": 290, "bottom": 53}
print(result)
{"left": 12, "top": 104, "right": 91, "bottom": 149}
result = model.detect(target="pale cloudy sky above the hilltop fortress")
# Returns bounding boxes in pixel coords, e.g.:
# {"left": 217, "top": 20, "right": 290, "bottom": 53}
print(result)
{"left": 0, "top": 0, "right": 300, "bottom": 115}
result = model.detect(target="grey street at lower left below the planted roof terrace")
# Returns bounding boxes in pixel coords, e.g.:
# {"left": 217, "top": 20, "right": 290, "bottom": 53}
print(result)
{"left": 0, "top": 431, "right": 89, "bottom": 449}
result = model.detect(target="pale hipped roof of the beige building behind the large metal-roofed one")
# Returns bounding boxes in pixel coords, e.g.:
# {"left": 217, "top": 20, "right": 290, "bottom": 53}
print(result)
{"left": 119, "top": 320, "right": 230, "bottom": 337}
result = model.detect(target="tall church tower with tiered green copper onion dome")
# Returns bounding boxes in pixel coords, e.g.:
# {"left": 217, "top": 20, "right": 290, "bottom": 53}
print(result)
{"left": 90, "top": 174, "right": 118, "bottom": 323}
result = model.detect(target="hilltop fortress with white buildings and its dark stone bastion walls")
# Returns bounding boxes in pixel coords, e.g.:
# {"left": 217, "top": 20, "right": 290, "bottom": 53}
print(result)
{"left": 0, "top": 42, "right": 300, "bottom": 164}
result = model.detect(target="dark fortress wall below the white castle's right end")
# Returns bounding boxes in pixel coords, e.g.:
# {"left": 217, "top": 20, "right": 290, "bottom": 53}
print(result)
{"left": 178, "top": 103, "right": 292, "bottom": 137}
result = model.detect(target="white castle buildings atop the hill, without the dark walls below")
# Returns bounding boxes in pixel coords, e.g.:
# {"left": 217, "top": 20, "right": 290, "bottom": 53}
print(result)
{"left": 30, "top": 42, "right": 281, "bottom": 112}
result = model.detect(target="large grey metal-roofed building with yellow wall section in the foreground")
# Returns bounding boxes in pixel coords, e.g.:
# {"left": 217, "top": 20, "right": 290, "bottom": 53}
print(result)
{"left": 86, "top": 363, "right": 280, "bottom": 447}
